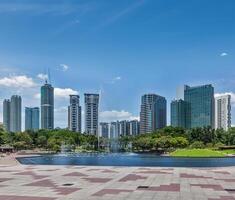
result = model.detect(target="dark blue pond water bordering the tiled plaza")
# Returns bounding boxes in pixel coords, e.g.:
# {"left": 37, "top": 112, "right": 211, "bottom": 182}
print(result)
{"left": 17, "top": 153, "right": 235, "bottom": 167}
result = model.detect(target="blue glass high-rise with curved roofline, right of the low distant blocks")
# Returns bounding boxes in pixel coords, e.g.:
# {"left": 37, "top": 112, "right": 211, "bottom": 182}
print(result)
{"left": 140, "top": 94, "right": 166, "bottom": 133}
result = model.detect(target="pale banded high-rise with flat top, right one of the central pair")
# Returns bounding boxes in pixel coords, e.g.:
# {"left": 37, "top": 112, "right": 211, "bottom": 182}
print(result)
{"left": 84, "top": 94, "right": 99, "bottom": 135}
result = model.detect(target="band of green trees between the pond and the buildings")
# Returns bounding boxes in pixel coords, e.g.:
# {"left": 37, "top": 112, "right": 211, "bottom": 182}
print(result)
{"left": 0, "top": 126, "right": 235, "bottom": 152}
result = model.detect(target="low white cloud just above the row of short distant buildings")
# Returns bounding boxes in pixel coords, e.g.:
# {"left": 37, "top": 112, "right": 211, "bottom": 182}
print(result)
{"left": 100, "top": 110, "right": 139, "bottom": 122}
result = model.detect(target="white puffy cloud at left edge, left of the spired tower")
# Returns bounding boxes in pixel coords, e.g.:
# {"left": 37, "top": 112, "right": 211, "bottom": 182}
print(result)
{"left": 0, "top": 75, "right": 37, "bottom": 88}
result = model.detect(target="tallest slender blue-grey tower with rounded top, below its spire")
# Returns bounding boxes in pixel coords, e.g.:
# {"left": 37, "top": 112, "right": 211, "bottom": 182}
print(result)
{"left": 41, "top": 82, "right": 54, "bottom": 129}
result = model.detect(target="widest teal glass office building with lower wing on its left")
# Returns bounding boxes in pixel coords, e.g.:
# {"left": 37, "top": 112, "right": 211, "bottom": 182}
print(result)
{"left": 171, "top": 84, "right": 215, "bottom": 129}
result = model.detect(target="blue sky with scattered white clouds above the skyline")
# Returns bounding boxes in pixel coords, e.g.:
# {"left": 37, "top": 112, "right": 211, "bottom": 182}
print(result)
{"left": 0, "top": 0, "right": 235, "bottom": 127}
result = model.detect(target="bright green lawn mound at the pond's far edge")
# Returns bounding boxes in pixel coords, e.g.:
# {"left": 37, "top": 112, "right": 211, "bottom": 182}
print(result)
{"left": 170, "top": 149, "right": 227, "bottom": 157}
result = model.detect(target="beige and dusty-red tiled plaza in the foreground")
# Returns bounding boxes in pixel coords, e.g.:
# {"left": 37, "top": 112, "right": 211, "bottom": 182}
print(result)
{"left": 0, "top": 165, "right": 235, "bottom": 200}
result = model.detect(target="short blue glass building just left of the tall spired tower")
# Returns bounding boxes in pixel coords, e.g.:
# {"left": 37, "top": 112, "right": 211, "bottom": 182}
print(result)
{"left": 25, "top": 107, "right": 39, "bottom": 131}
